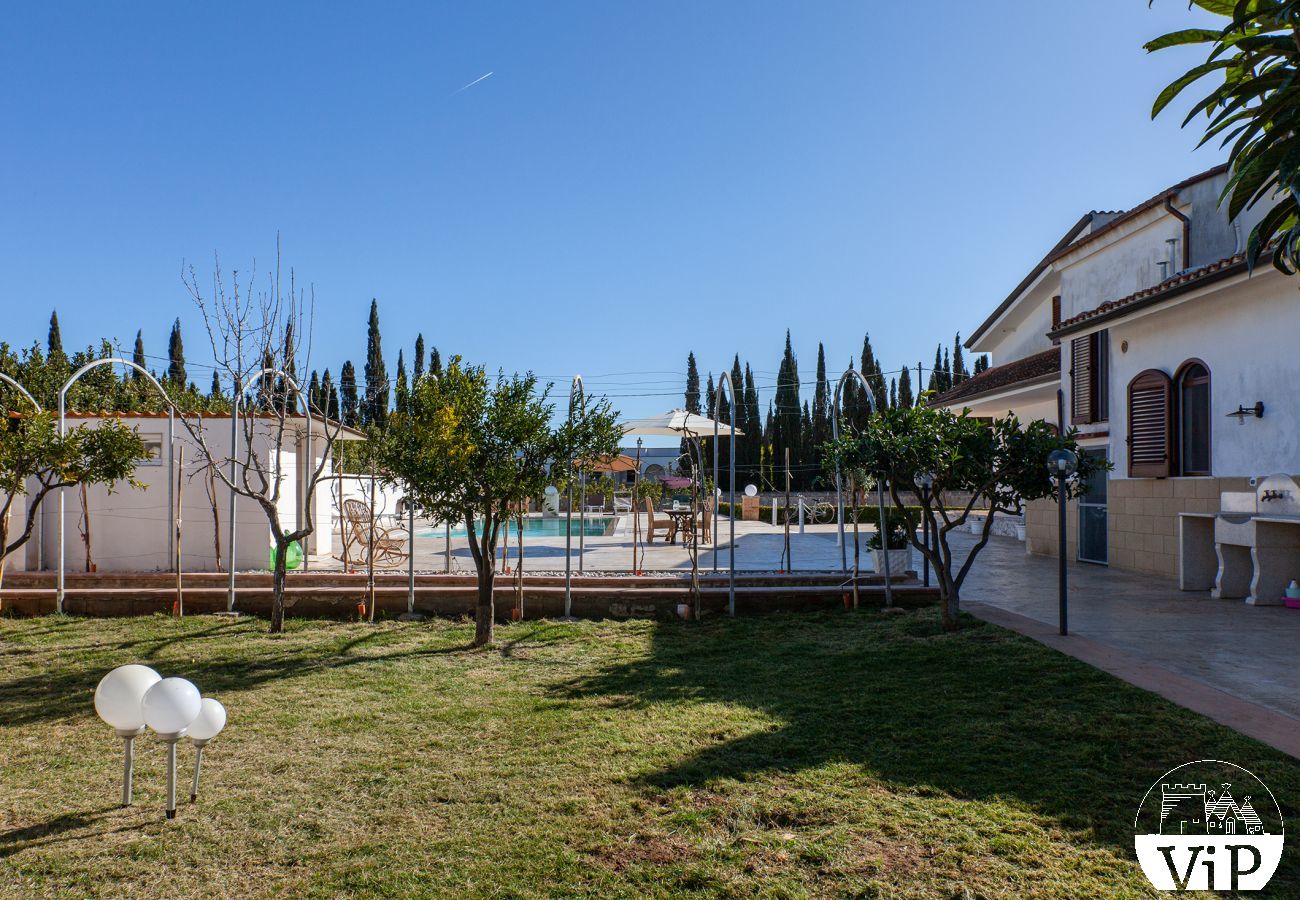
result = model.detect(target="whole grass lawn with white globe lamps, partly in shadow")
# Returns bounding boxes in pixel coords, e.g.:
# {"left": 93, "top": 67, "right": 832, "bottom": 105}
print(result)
{"left": 0, "top": 610, "right": 1300, "bottom": 897}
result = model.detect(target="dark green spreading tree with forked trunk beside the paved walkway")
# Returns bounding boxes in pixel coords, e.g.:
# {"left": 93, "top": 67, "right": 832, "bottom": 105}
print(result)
{"left": 826, "top": 406, "right": 1109, "bottom": 629}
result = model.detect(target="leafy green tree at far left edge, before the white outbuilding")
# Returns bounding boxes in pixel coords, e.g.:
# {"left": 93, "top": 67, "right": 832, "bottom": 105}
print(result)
{"left": 0, "top": 404, "right": 147, "bottom": 593}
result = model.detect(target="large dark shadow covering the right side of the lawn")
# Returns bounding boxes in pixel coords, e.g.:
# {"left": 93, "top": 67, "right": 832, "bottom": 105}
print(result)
{"left": 559, "top": 610, "right": 1300, "bottom": 875}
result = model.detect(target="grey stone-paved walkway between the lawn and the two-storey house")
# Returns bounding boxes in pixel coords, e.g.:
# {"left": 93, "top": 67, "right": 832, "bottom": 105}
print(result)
{"left": 958, "top": 537, "right": 1300, "bottom": 756}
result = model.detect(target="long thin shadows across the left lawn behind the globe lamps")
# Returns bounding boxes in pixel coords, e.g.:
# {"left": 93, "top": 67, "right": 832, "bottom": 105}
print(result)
{"left": 0, "top": 619, "right": 475, "bottom": 726}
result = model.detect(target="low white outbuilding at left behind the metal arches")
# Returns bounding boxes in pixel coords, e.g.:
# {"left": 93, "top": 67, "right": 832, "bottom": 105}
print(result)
{"left": 8, "top": 412, "right": 364, "bottom": 572}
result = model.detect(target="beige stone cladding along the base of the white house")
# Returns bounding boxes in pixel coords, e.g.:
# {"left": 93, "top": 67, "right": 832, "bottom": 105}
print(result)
{"left": 1024, "top": 476, "right": 1251, "bottom": 579}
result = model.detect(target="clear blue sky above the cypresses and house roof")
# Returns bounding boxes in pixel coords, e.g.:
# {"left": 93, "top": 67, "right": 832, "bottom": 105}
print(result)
{"left": 0, "top": 0, "right": 1221, "bottom": 431}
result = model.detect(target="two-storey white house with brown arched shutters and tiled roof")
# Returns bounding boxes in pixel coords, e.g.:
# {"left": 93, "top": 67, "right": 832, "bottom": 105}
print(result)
{"left": 939, "top": 166, "right": 1300, "bottom": 587}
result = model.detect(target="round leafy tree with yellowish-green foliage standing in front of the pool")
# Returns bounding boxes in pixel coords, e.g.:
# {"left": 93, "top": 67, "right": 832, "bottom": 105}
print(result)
{"left": 378, "top": 356, "right": 623, "bottom": 646}
